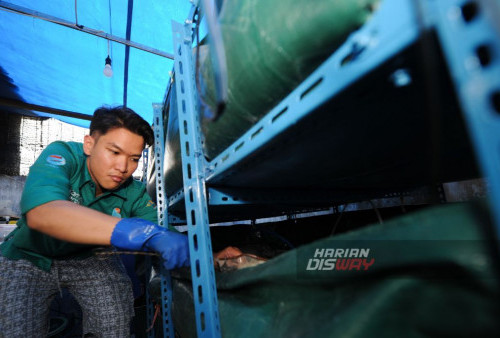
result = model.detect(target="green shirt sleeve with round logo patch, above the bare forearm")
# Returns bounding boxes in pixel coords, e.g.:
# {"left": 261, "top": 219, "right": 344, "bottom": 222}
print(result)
{"left": 21, "top": 141, "right": 77, "bottom": 214}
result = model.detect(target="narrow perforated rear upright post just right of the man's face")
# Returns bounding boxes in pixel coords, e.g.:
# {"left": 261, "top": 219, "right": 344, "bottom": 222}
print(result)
{"left": 146, "top": 104, "right": 175, "bottom": 337}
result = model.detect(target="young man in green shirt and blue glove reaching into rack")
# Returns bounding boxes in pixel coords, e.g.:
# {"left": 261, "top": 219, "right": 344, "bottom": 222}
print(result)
{"left": 0, "top": 107, "right": 189, "bottom": 338}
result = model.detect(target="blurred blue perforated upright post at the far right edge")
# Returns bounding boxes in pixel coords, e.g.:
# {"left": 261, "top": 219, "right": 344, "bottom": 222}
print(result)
{"left": 429, "top": 0, "right": 500, "bottom": 238}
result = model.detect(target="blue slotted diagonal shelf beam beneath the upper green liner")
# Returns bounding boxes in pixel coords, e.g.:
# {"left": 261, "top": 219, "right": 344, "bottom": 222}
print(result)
{"left": 168, "top": 0, "right": 421, "bottom": 214}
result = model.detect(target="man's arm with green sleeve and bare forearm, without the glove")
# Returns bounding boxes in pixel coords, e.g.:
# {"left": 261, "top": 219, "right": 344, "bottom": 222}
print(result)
{"left": 21, "top": 142, "right": 119, "bottom": 245}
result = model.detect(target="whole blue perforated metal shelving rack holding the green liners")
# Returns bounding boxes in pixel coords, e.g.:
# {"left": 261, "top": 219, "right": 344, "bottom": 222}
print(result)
{"left": 156, "top": 0, "right": 500, "bottom": 336}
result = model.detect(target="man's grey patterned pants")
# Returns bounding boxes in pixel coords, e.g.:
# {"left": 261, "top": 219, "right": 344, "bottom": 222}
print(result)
{"left": 0, "top": 255, "right": 134, "bottom": 338}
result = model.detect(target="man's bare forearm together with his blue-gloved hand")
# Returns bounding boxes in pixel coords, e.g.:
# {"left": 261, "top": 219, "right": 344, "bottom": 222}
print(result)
{"left": 27, "top": 200, "right": 189, "bottom": 270}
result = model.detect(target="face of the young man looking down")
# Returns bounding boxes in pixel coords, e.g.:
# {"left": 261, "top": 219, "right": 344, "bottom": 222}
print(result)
{"left": 83, "top": 128, "right": 144, "bottom": 196}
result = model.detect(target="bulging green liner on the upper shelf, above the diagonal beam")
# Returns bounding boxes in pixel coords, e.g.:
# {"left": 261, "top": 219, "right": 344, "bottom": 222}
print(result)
{"left": 165, "top": 0, "right": 380, "bottom": 194}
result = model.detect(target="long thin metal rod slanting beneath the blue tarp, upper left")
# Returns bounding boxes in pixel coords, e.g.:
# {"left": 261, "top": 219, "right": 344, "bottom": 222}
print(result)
{"left": 0, "top": 1, "right": 174, "bottom": 60}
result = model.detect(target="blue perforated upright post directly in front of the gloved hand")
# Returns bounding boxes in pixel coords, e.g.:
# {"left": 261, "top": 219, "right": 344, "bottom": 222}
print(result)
{"left": 172, "top": 22, "right": 221, "bottom": 337}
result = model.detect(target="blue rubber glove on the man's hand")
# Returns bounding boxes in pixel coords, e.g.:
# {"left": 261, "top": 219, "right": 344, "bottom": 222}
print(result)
{"left": 111, "top": 218, "right": 189, "bottom": 270}
